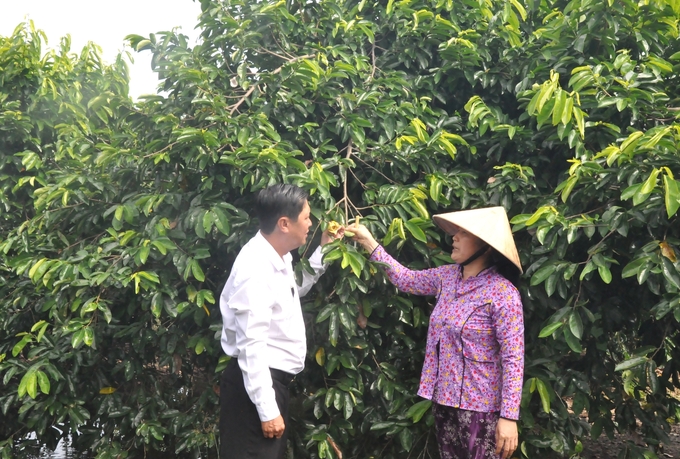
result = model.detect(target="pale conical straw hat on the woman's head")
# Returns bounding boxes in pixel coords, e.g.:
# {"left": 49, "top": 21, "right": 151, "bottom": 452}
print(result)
{"left": 432, "top": 207, "right": 524, "bottom": 273}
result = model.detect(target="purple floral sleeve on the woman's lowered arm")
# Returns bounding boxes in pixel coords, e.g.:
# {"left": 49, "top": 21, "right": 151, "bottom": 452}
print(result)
{"left": 493, "top": 283, "right": 524, "bottom": 420}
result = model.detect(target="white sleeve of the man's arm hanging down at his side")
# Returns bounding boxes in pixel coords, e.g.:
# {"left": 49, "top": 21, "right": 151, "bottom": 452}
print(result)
{"left": 228, "top": 275, "right": 280, "bottom": 422}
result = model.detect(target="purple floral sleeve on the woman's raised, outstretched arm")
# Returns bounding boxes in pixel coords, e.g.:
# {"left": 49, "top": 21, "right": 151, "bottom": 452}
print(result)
{"left": 370, "top": 245, "right": 442, "bottom": 295}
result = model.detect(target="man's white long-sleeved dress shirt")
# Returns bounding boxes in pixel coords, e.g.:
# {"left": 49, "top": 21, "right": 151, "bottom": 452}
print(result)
{"left": 220, "top": 232, "right": 326, "bottom": 422}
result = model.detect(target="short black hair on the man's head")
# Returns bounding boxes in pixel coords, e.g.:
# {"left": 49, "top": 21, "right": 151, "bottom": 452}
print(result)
{"left": 255, "top": 184, "right": 309, "bottom": 234}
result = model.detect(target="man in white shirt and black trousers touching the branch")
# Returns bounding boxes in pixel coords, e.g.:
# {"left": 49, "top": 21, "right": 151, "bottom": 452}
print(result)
{"left": 220, "top": 185, "right": 344, "bottom": 459}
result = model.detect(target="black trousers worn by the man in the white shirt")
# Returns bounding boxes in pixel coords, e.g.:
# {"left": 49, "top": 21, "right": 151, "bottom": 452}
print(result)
{"left": 220, "top": 359, "right": 293, "bottom": 459}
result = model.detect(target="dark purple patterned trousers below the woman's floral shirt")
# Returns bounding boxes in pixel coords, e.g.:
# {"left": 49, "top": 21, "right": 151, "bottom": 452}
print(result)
{"left": 432, "top": 404, "right": 500, "bottom": 459}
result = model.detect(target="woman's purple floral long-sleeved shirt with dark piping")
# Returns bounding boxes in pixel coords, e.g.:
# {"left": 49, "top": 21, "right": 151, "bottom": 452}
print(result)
{"left": 371, "top": 246, "right": 524, "bottom": 419}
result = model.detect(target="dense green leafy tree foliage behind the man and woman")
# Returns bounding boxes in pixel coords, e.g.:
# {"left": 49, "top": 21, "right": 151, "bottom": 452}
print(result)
{"left": 0, "top": 0, "right": 680, "bottom": 459}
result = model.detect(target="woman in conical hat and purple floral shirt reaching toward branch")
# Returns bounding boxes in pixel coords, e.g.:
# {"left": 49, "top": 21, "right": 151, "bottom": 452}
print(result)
{"left": 347, "top": 207, "right": 524, "bottom": 459}
